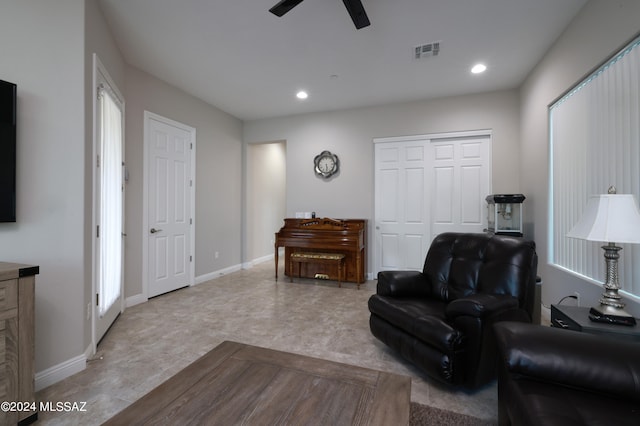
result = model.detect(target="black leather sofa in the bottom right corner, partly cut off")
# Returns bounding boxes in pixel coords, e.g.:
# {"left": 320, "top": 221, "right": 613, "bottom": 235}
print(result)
{"left": 494, "top": 322, "right": 640, "bottom": 426}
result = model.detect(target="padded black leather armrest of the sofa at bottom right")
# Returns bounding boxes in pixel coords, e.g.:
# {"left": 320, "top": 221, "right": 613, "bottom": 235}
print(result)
{"left": 494, "top": 322, "right": 640, "bottom": 401}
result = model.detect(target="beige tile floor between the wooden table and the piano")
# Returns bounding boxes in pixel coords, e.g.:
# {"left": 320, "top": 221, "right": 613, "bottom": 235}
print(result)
{"left": 35, "top": 262, "right": 497, "bottom": 426}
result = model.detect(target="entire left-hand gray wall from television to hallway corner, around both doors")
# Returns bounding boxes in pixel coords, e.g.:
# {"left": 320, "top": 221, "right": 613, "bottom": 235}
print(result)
{"left": 0, "top": 0, "right": 242, "bottom": 376}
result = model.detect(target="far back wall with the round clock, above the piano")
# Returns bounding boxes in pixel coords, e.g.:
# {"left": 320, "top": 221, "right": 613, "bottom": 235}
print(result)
{"left": 244, "top": 90, "right": 526, "bottom": 272}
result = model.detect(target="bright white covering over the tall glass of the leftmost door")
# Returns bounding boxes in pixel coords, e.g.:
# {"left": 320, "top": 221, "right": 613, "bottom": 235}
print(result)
{"left": 98, "top": 88, "right": 123, "bottom": 315}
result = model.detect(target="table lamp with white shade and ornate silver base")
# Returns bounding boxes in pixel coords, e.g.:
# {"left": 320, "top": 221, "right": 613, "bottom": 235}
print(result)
{"left": 567, "top": 187, "right": 640, "bottom": 326}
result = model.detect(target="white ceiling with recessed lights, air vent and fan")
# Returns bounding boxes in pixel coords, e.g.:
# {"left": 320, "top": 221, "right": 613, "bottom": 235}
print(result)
{"left": 99, "top": 0, "right": 587, "bottom": 120}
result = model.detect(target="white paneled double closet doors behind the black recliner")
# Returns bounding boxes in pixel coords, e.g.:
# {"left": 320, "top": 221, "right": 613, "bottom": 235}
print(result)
{"left": 374, "top": 132, "right": 491, "bottom": 274}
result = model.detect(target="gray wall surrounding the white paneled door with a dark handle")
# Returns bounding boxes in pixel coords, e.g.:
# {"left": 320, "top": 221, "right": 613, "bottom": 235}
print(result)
{"left": 124, "top": 66, "right": 242, "bottom": 298}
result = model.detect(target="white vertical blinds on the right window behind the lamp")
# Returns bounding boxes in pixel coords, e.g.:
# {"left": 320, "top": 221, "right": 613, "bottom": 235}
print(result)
{"left": 549, "top": 38, "right": 640, "bottom": 295}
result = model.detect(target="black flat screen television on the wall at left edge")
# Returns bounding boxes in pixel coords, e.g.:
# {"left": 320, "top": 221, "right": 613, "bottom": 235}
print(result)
{"left": 0, "top": 80, "right": 16, "bottom": 222}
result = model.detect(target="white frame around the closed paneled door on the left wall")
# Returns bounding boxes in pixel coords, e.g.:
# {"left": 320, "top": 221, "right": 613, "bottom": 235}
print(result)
{"left": 142, "top": 110, "right": 196, "bottom": 300}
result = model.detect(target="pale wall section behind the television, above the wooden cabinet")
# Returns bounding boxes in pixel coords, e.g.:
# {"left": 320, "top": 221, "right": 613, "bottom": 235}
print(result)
{"left": 0, "top": 0, "right": 85, "bottom": 371}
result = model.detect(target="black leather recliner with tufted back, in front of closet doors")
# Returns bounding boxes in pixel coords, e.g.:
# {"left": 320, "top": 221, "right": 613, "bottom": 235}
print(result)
{"left": 369, "top": 233, "right": 538, "bottom": 388}
